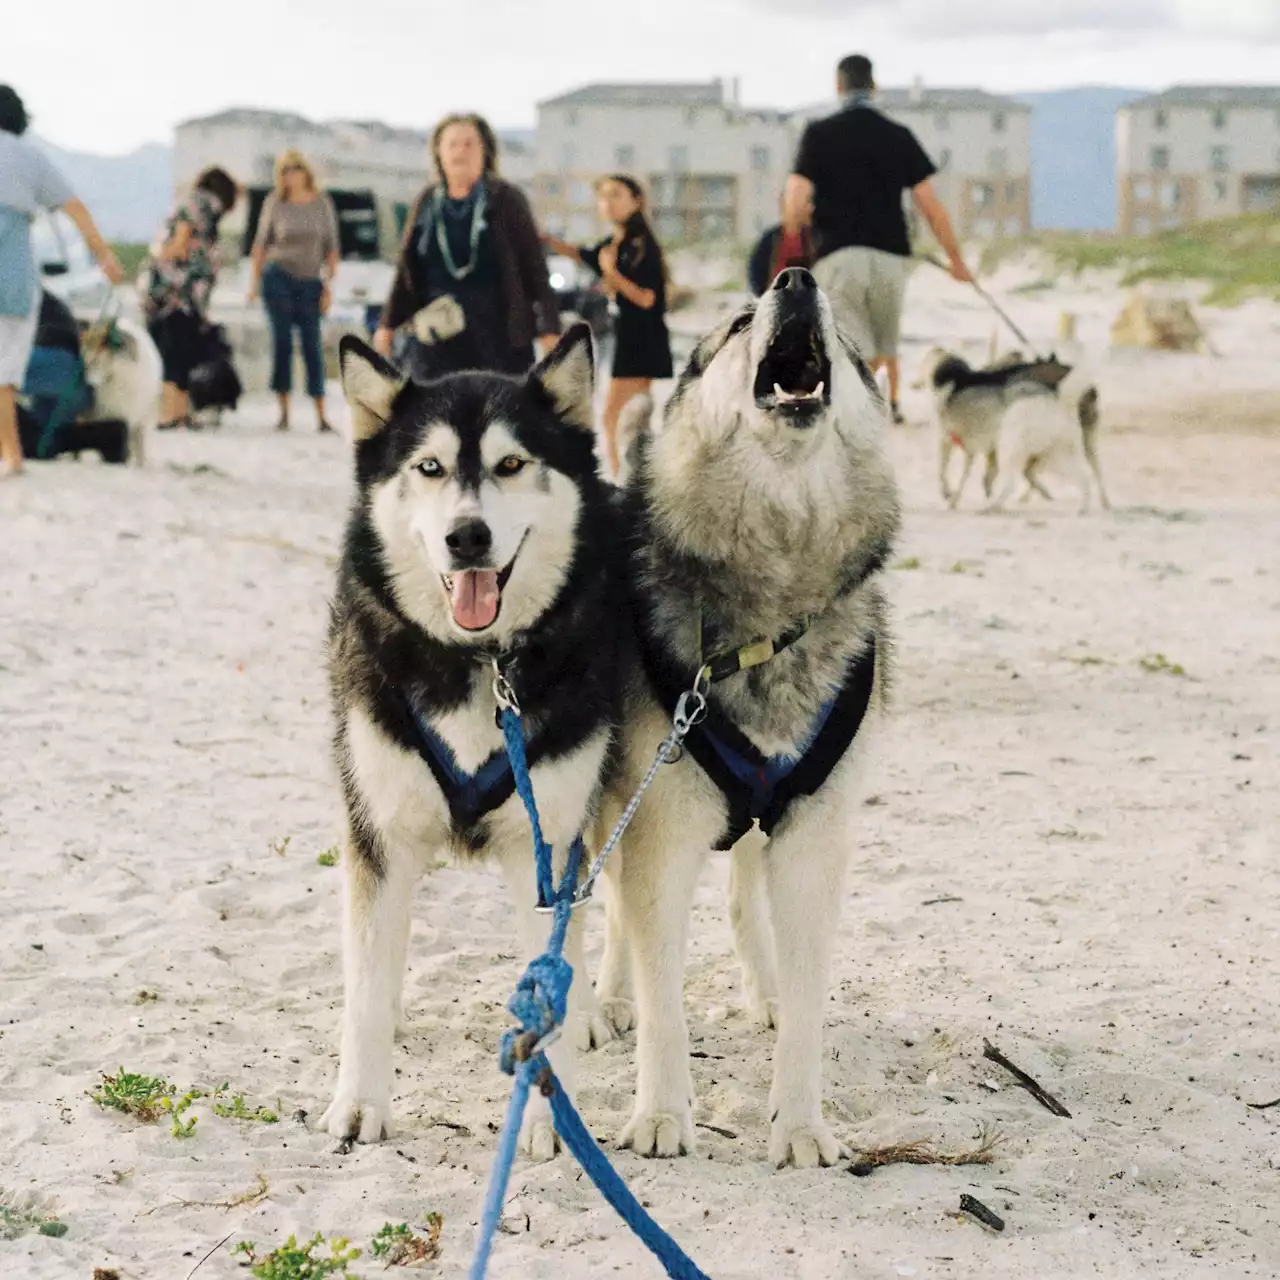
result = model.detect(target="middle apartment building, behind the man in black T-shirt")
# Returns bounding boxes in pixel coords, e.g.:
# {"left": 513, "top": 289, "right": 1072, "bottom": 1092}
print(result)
{"left": 532, "top": 79, "right": 1030, "bottom": 241}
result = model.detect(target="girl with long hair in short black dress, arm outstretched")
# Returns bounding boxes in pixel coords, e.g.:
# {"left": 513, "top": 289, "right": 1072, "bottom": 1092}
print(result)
{"left": 547, "top": 173, "right": 672, "bottom": 475}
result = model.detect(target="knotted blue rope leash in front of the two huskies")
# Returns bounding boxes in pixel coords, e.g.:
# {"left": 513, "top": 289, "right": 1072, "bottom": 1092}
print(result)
{"left": 470, "top": 707, "right": 709, "bottom": 1280}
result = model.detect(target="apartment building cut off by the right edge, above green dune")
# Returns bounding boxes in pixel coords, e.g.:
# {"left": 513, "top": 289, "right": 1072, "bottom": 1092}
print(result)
{"left": 1116, "top": 84, "right": 1280, "bottom": 236}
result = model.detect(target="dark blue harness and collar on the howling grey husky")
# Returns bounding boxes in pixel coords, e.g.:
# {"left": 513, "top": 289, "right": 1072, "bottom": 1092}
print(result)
{"left": 640, "top": 618, "right": 876, "bottom": 849}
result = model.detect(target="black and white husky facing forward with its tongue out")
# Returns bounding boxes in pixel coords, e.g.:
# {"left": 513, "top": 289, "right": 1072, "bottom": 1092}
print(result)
{"left": 321, "top": 325, "right": 623, "bottom": 1158}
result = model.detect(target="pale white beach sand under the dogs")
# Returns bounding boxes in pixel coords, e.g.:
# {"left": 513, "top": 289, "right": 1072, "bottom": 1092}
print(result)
{"left": 0, "top": 267, "right": 1280, "bottom": 1280}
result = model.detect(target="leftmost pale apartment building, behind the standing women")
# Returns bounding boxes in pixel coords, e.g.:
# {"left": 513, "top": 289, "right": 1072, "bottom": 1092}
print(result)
{"left": 173, "top": 108, "right": 534, "bottom": 259}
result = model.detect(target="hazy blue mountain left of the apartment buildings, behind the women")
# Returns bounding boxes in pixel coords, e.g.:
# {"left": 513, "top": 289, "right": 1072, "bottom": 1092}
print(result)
{"left": 35, "top": 138, "right": 173, "bottom": 243}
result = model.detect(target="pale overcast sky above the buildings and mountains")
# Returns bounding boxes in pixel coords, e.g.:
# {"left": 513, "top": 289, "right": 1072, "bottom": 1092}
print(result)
{"left": 10, "top": 0, "right": 1280, "bottom": 152}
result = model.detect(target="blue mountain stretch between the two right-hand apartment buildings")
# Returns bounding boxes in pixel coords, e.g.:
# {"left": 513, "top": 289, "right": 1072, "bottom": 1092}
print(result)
{"left": 1014, "top": 86, "right": 1148, "bottom": 232}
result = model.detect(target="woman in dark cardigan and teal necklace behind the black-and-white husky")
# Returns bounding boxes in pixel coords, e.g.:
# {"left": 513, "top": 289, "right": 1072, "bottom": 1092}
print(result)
{"left": 374, "top": 115, "right": 559, "bottom": 381}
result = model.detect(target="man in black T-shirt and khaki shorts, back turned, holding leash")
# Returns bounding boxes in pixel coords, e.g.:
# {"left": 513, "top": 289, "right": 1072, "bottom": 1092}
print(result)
{"left": 783, "top": 54, "right": 973, "bottom": 422}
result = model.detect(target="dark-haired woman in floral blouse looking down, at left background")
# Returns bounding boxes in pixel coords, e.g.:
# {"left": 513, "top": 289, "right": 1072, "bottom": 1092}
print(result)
{"left": 142, "top": 168, "right": 239, "bottom": 430}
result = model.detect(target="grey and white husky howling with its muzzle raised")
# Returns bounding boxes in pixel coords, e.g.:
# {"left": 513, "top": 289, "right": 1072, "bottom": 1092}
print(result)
{"left": 598, "top": 269, "right": 899, "bottom": 1166}
